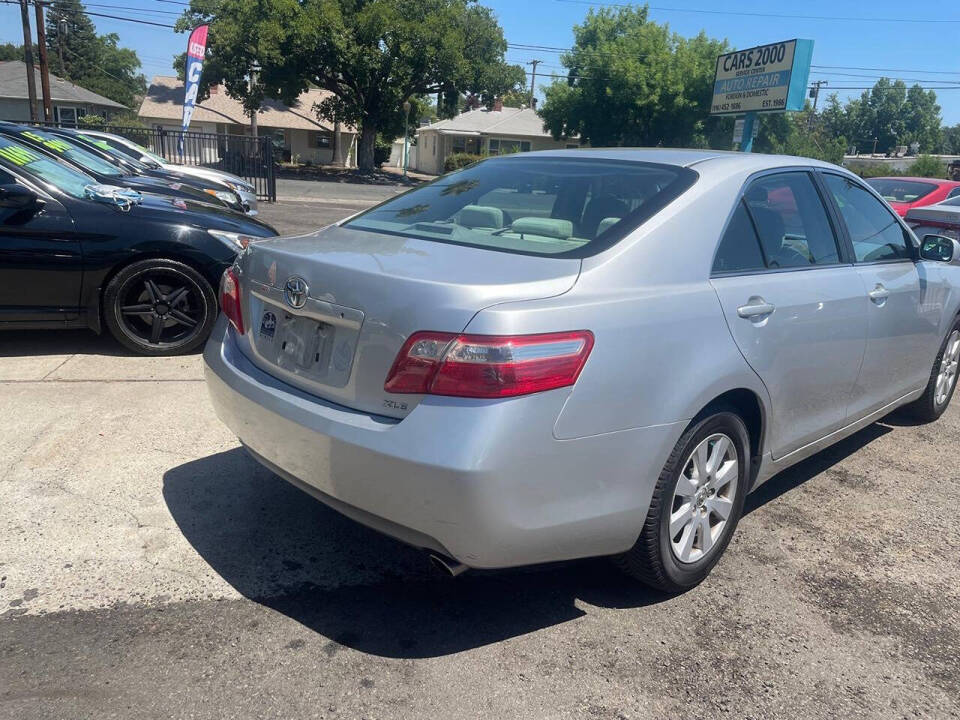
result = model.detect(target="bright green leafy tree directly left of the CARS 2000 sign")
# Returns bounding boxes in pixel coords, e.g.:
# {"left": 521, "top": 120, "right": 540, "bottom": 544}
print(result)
{"left": 540, "top": 7, "right": 732, "bottom": 146}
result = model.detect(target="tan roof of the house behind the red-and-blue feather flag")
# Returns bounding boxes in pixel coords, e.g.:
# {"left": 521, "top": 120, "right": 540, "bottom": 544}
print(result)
{"left": 137, "top": 75, "right": 355, "bottom": 132}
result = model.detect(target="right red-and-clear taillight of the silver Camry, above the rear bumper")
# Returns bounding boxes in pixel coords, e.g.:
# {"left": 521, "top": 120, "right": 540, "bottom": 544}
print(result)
{"left": 383, "top": 330, "right": 593, "bottom": 398}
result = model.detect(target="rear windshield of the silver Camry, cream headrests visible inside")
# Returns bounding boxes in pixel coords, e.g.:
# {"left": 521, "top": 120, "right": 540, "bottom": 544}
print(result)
{"left": 344, "top": 155, "right": 697, "bottom": 257}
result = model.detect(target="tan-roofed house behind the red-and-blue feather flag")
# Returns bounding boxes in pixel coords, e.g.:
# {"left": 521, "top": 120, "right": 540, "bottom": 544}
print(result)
{"left": 137, "top": 75, "right": 357, "bottom": 165}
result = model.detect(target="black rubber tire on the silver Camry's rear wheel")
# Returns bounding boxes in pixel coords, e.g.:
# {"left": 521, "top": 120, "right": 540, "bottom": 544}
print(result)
{"left": 615, "top": 408, "right": 750, "bottom": 593}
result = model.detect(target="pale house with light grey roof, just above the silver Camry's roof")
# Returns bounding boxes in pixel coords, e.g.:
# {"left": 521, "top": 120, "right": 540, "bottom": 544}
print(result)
{"left": 407, "top": 103, "right": 580, "bottom": 175}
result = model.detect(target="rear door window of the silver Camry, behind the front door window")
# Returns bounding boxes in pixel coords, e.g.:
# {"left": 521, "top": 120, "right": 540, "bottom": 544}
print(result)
{"left": 743, "top": 172, "right": 840, "bottom": 270}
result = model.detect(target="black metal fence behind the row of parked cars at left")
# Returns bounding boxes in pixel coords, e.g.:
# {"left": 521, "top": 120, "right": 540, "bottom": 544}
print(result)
{"left": 14, "top": 123, "right": 277, "bottom": 202}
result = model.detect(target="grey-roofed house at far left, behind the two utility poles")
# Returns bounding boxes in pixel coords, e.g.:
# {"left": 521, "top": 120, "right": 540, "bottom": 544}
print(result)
{"left": 0, "top": 60, "right": 127, "bottom": 125}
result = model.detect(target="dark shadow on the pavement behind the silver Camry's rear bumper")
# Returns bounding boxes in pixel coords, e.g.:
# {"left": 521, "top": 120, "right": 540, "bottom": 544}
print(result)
{"left": 163, "top": 448, "right": 669, "bottom": 658}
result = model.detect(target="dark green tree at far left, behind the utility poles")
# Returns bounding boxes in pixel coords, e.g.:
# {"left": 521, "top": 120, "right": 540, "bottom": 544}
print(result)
{"left": 46, "top": 0, "right": 147, "bottom": 107}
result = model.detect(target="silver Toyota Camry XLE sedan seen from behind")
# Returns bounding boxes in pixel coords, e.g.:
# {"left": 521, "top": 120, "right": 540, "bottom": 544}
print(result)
{"left": 204, "top": 149, "right": 960, "bottom": 592}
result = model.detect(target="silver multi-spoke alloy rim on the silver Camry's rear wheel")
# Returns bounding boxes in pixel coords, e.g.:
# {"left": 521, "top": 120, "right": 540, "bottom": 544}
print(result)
{"left": 669, "top": 434, "right": 740, "bottom": 563}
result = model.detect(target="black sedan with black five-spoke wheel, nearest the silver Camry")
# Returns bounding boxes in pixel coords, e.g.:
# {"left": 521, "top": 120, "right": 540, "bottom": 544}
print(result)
{"left": 0, "top": 135, "right": 277, "bottom": 355}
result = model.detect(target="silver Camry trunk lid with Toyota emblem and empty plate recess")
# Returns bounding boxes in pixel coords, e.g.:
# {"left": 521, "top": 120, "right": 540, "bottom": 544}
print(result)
{"left": 234, "top": 226, "right": 580, "bottom": 418}
